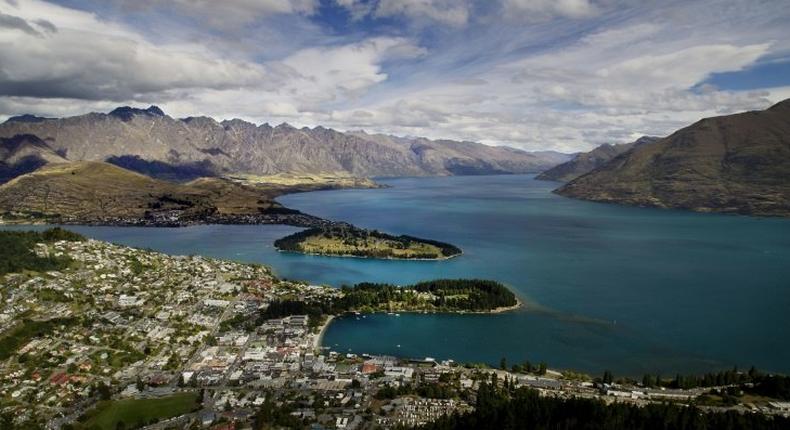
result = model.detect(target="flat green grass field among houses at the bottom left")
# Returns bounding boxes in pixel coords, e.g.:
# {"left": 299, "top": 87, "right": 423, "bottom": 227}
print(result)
{"left": 79, "top": 392, "right": 198, "bottom": 430}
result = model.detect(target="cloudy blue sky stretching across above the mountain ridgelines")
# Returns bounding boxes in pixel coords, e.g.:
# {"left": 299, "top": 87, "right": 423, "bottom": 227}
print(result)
{"left": 0, "top": 0, "right": 790, "bottom": 152}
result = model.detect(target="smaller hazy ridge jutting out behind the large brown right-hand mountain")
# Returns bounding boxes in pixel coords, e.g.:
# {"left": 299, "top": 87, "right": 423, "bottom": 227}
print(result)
{"left": 535, "top": 136, "right": 659, "bottom": 182}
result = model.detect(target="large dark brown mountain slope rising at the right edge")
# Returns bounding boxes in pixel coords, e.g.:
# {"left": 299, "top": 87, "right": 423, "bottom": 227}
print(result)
{"left": 557, "top": 99, "right": 790, "bottom": 216}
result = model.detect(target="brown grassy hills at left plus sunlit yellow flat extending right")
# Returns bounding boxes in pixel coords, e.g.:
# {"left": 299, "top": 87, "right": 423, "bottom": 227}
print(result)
{"left": 0, "top": 161, "right": 384, "bottom": 224}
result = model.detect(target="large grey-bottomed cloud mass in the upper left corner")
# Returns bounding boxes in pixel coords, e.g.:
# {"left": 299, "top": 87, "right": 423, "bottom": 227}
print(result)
{"left": 0, "top": 1, "right": 268, "bottom": 100}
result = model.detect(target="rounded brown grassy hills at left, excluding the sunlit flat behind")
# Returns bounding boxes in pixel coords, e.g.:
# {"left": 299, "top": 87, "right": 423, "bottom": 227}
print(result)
{"left": 0, "top": 161, "right": 310, "bottom": 222}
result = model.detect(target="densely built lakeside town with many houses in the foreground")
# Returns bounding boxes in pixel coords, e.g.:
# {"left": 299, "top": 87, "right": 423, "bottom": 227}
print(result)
{"left": 0, "top": 239, "right": 790, "bottom": 429}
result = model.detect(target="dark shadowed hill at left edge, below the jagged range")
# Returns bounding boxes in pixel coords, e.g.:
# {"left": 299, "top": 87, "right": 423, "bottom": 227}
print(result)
{"left": 0, "top": 134, "right": 65, "bottom": 184}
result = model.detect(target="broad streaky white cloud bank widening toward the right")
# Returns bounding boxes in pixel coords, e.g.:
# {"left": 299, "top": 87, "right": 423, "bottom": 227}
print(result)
{"left": 312, "top": 32, "right": 779, "bottom": 151}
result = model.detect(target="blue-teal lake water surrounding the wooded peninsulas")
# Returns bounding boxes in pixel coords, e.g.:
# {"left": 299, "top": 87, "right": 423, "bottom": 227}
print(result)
{"left": 7, "top": 175, "right": 790, "bottom": 375}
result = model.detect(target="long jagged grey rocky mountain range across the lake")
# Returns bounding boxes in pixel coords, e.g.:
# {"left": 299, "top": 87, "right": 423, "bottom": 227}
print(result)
{"left": 0, "top": 106, "right": 565, "bottom": 180}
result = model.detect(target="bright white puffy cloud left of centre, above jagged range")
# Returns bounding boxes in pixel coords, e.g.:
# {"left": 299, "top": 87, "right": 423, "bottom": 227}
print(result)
{"left": 145, "top": 38, "right": 426, "bottom": 125}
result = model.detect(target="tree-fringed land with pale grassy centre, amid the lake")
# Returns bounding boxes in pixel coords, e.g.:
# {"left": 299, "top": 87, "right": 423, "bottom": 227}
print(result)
{"left": 274, "top": 223, "right": 461, "bottom": 260}
